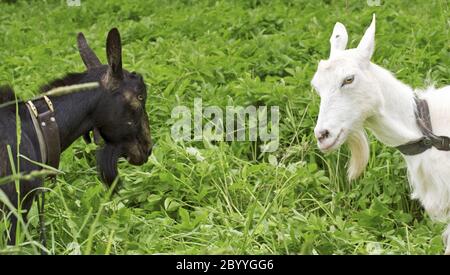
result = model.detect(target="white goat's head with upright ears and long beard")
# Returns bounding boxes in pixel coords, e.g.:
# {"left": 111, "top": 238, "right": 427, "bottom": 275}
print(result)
{"left": 311, "top": 15, "right": 381, "bottom": 179}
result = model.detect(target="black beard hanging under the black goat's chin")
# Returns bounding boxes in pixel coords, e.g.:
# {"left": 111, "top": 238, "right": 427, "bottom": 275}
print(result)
{"left": 96, "top": 143, "right": 123, "bottom": 189}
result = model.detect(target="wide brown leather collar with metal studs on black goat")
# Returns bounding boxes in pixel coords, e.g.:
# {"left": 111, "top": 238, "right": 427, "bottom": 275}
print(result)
{"left": 26, "top": 96, "right": 61, "bottom": 169}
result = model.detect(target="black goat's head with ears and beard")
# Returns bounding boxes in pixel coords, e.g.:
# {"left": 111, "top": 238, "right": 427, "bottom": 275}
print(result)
{"left": 77, "top": 28, "right": 152, "bottom": 187}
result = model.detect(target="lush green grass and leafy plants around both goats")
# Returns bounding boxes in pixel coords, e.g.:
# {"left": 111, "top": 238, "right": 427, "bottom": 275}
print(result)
{"left": 0, "top": 0, "right": 450, "bottom": 254}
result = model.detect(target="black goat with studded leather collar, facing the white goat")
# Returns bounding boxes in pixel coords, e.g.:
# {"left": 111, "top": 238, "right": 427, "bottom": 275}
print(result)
{"left": 0, "top": 28, "right": 152, "bottom": 244}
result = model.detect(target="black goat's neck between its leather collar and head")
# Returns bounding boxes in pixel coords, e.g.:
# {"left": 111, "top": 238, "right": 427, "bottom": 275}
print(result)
{"left": 35, "top": 90, "right": 102, "bottom": 152}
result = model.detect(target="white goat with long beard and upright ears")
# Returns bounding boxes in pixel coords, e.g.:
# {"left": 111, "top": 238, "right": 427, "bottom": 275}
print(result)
{"left": 311, "top": 15, "right": 450, "bottom": 254}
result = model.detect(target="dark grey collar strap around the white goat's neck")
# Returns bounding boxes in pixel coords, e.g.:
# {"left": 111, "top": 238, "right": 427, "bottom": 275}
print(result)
{"left": 396, "top": 97, "right": 450, "bottom": 156}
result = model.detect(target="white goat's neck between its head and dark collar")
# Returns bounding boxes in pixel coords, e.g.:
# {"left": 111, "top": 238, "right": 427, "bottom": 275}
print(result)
{"left": 365, "top": 63, "right": 422, "bottom": 146}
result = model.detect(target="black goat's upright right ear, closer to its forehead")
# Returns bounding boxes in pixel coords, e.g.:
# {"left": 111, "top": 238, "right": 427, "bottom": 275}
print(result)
{"left": 106, "top": 28, "right": 123, "bottom": 86}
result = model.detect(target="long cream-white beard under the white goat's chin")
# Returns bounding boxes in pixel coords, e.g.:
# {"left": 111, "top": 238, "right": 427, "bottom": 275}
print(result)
{"left": 347, "top": 129, "right": 370, "bottom": 180}
